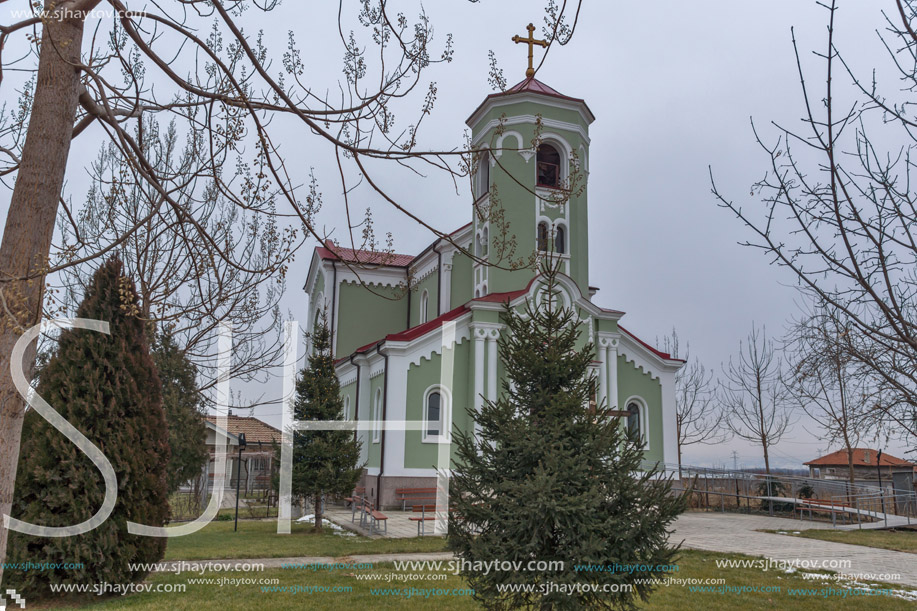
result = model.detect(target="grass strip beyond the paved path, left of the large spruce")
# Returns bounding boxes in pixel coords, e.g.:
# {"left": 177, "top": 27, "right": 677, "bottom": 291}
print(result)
{"left": 165, "top": 520, "right": 446, "bottom": 560}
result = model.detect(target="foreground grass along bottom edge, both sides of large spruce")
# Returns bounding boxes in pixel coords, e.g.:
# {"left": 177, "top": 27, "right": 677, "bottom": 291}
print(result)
{"left": 52, "top": 550, "right": 914, "bottom": 611}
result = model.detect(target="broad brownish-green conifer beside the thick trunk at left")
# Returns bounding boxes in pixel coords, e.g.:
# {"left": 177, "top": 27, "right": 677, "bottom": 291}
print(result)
{"left": 4, "top": 259, "right": 169, "bottom": 597}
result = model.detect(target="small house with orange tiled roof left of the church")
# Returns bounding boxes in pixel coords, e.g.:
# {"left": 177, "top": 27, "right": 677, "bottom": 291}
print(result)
{"left": 203, "top": 414, "right": 281, "bottom": 492}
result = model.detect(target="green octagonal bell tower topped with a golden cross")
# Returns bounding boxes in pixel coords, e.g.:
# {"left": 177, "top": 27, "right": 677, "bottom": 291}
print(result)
{"left": 466, "top": 30, "right": 595, "bottom": 297}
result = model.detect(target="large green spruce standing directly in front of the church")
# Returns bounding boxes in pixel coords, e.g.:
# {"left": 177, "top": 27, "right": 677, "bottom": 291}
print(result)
{"left": 448, "top": 266, "right": 683, "bottom": 609}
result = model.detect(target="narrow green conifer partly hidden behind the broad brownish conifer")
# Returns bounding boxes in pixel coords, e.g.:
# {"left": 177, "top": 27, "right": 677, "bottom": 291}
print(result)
{"left": 152, "top": 331, "right": 210, "bottom": 494}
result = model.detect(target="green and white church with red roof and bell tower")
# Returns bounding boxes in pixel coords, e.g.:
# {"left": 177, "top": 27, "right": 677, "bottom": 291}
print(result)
{"left": 305, "top": 43, "right": 683, "bottom": 507}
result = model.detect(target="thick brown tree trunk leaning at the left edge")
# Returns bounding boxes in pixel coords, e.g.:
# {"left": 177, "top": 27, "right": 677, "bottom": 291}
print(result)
{"left": 0, "top": 2, "right": 83, "bottom": 579}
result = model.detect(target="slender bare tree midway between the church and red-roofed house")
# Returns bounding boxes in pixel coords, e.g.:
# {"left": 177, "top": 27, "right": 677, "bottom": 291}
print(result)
{"left": 719, "top": 324, "right": 790, "bottom": 475}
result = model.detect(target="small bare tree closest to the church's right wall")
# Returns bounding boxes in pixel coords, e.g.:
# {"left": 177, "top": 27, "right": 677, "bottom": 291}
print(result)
{"left": 663, "top": 329, "right": 729, "bottom": 470}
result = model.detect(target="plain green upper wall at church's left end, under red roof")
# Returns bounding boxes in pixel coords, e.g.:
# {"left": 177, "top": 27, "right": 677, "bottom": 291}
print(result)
{"left": 335, "top": 282, "right": 407, "bottom": 358}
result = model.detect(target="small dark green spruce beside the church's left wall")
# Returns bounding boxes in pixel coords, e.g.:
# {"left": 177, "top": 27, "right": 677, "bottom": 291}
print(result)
{"left": 286, "top": 315, "right": 362, "bottom": 530}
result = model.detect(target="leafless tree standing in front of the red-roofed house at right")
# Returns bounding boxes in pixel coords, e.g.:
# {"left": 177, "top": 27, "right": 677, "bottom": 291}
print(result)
{"left": 788, "top": 305, "right": 883, "bottom": 483}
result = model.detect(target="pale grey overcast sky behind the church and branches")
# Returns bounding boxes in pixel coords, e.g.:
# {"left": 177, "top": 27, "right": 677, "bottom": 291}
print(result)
{"left": 4, "top": 0, "right": 904, "bottom": 467}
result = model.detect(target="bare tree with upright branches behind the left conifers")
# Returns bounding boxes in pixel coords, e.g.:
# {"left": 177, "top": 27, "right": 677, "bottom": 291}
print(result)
{"left": 53, "top": 119, "right": 298, "bottom": 391}
